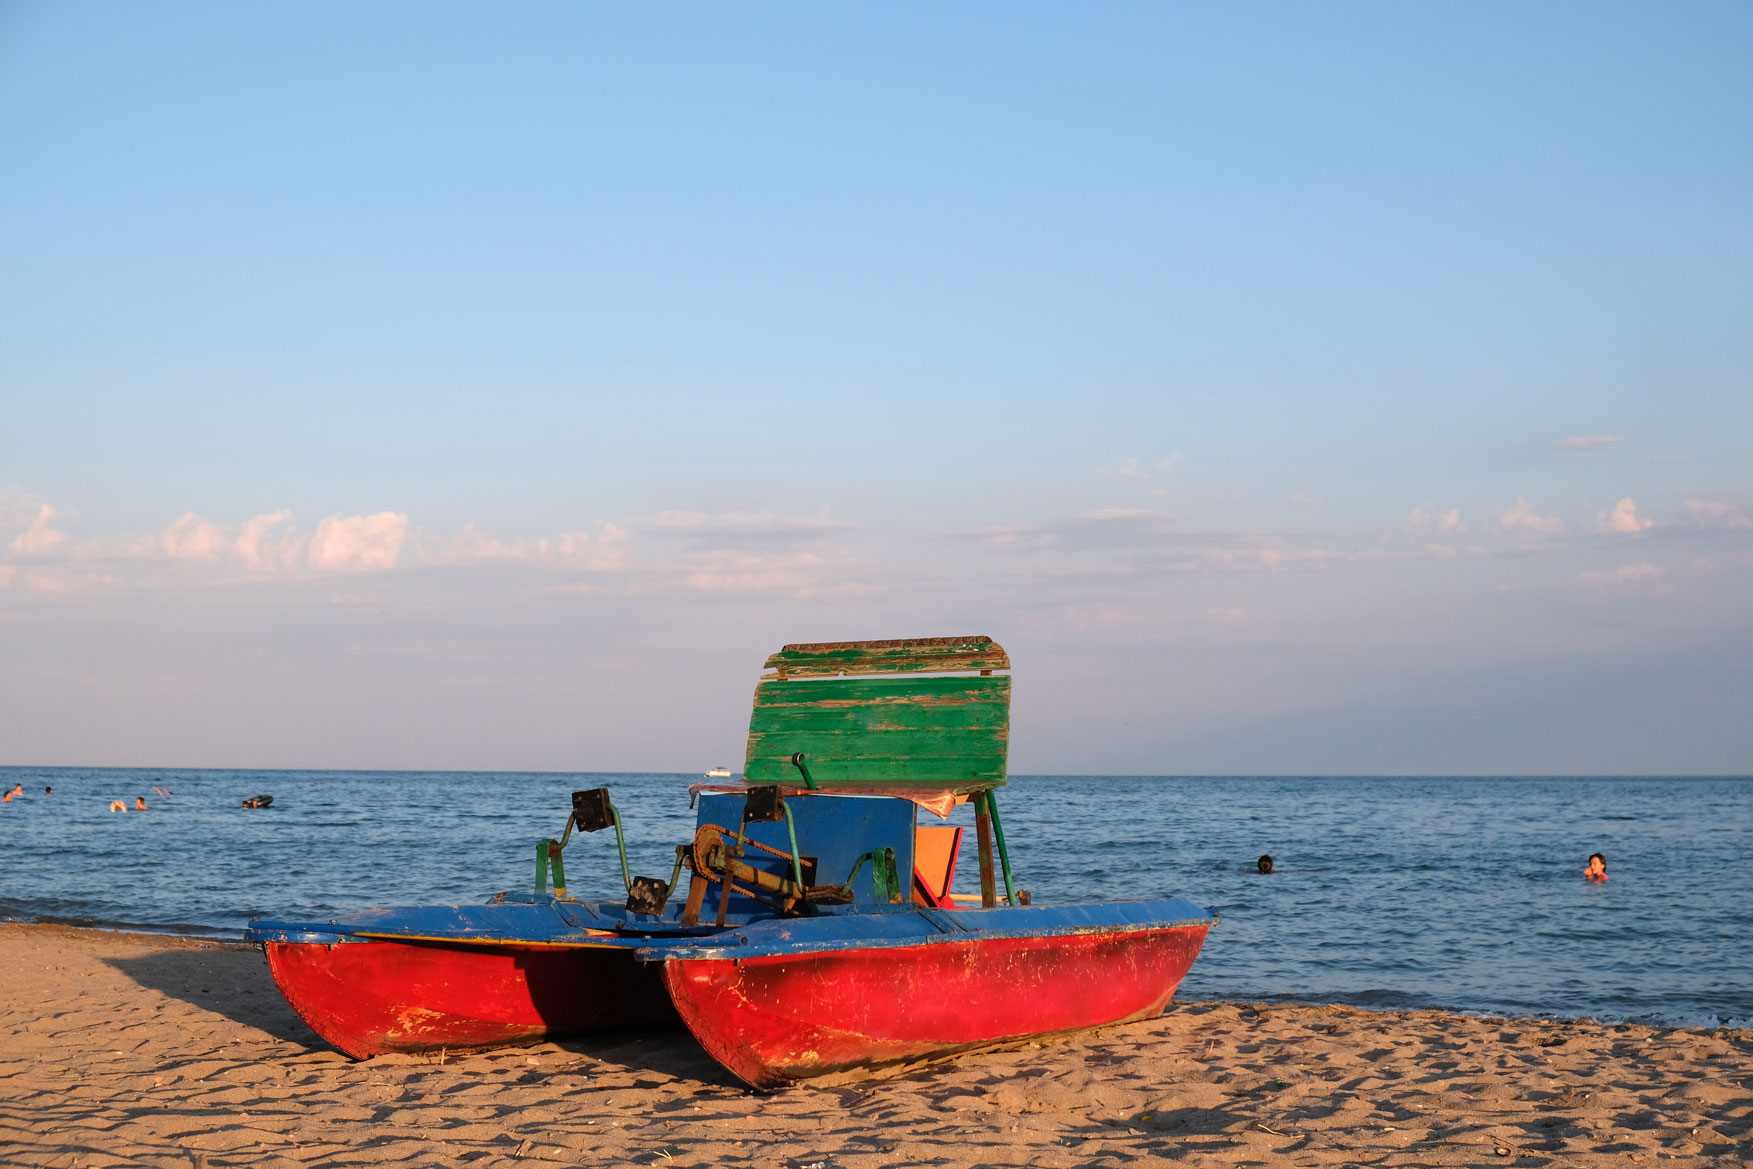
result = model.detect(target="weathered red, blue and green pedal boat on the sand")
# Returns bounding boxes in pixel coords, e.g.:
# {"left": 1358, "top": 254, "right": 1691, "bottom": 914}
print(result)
{"left": 245, "top": 638, "right": 1217, "bottom": 1088}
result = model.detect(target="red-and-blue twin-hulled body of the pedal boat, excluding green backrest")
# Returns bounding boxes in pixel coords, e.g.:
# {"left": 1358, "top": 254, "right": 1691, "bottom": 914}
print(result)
{"left": 245, "top": 781, "right": 1217, "bottom": 1087}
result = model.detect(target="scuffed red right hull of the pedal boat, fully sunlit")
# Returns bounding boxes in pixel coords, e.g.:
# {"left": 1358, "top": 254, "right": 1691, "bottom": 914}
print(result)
{"left": 663, "top": 925, "right": 1208, "bottom": 1088}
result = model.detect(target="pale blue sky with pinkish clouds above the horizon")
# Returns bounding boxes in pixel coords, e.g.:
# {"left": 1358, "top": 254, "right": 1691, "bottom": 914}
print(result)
{"left": 0, "top": 0, "right": 1753, "bottom": 775}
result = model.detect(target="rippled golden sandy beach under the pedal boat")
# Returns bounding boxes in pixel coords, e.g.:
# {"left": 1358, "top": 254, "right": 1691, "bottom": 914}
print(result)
{"left": 0, "top": 925, "right": 1753, "bottom": 1169}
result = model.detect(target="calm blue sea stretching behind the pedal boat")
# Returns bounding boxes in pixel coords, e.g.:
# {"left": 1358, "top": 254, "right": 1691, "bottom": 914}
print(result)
{"left": 0, "top": 768, "right": 1753, "bottom": 1025}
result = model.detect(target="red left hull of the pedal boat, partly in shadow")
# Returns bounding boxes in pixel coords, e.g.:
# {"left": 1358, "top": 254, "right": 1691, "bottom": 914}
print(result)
{"left": 265, "top": 939, "right": 675, "bottom": 1059}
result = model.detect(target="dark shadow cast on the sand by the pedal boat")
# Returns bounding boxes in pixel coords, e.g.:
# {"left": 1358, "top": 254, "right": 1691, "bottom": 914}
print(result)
{"left": 103, "top": 943, "right": 742, "bottom": 1088}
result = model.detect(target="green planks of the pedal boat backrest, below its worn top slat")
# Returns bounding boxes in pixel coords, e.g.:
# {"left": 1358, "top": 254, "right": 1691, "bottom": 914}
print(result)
{"left": 743, "top": 677, "right": 1010, "bottom": 790}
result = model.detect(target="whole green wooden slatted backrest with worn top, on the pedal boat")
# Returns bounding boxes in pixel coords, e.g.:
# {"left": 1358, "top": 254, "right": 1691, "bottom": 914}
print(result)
{"left": 743, "top": 638, "right": 1010, "bottom": 790}
